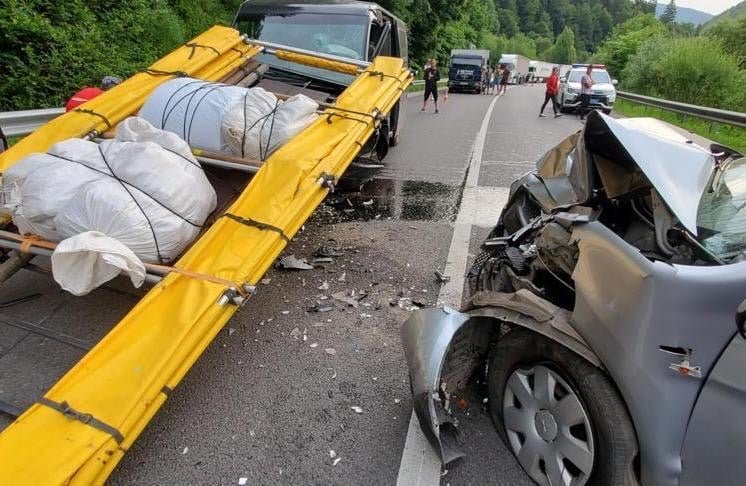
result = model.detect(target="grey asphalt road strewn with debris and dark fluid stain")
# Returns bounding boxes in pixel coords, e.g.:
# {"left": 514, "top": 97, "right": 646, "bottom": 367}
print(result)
{"left": 0, "top": 86, "right": 581, "bottom": 485}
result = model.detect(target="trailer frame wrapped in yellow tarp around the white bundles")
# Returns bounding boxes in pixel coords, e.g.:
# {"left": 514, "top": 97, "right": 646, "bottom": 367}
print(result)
{"left": 0, "top": 22, "right": 412, "bottom": 484}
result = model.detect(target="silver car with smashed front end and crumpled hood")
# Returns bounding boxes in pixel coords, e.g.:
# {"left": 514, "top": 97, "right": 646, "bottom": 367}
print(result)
{"left": 402, "top": 112, "right": 746, "bottom": 485}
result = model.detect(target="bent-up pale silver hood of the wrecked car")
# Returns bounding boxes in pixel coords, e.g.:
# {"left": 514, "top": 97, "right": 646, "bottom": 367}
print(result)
{"left": 589, "top": 113, "right": 715, "bottom": 236}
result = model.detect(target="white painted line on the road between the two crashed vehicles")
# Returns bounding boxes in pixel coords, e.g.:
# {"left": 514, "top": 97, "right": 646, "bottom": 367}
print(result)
{"left": 396, "top": 95, "right": 508, "bottom": 486}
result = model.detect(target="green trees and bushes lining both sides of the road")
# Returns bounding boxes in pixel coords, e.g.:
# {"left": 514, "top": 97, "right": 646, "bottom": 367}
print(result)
{"left": 0, "top": 0, "right": 746, "bottom": 111}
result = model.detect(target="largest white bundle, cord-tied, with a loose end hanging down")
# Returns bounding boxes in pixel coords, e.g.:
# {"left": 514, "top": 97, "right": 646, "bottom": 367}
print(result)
{"left": 2, "top": 118, "right": 217, "bottom": 295}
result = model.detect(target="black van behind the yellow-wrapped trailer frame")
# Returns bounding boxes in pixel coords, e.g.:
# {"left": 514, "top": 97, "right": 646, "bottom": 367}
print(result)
{"left": 233, "top": 0, "right": 409, "bottom": 186}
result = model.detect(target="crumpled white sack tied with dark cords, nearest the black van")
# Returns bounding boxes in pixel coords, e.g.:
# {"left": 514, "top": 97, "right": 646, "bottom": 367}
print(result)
{"left": 223, "top": 88, "right": 319, "bottom": 160}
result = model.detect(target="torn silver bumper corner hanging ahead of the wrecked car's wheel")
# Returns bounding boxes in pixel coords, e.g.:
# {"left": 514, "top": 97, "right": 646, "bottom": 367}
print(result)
{"left": 401, "top": 307, "right": 471, "bottom": 464}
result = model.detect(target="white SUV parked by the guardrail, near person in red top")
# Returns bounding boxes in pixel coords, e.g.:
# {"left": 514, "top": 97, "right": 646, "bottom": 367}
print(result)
{"left": 559, "top": 64, "right": 618, "bottom": 115}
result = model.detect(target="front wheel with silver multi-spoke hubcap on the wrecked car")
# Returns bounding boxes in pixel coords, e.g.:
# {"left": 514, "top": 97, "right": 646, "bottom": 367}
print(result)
{"left": 488, "top": 329, "right": 637, "bottom": 485}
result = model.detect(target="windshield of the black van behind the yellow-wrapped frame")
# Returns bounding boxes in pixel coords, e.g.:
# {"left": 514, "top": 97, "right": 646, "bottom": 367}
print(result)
{"left": 236, "top": 13, "right": 369, "bottom": 85}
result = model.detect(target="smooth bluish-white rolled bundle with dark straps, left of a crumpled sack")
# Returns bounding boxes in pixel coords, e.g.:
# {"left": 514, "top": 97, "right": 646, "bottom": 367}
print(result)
{"left": 139, "top": 78, "right": 247, "bottom": 152}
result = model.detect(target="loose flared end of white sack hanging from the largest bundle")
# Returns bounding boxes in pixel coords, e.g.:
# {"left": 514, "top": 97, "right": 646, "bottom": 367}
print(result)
{"left": 52, "top": 231, "right": 145, "bottom": 295}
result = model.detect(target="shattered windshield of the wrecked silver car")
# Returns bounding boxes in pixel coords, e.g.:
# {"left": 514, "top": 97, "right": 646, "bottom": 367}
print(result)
{"left": 697, "top": 158, "right": 746, "bottom": 259}
